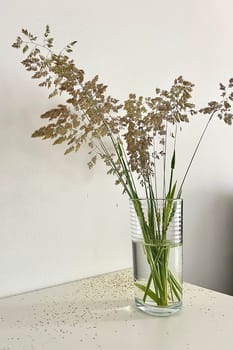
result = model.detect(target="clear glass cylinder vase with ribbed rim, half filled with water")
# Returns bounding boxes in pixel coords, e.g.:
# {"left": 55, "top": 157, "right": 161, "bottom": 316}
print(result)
{"left": 130, "top": 199, "right": 183, "bottom": 316}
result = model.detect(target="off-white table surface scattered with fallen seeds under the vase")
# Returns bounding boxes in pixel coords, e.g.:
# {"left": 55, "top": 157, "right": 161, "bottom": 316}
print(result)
{"left": 0, "top": 269, "right": 233, "bottom": 350}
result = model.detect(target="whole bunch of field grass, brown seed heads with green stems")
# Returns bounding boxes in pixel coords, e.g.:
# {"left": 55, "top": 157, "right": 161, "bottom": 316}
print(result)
{"left": 13, "top": 26, "right": 233, "bottom": 309}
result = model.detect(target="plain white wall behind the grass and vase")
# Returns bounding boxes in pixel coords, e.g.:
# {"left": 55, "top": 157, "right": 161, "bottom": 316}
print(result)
{"left": 0, "top": 0, "right": 233, "bottom": 296}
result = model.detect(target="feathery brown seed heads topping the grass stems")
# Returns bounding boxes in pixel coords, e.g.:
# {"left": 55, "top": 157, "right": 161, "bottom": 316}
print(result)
{"left": 12, "top": 26, "right": 233, "bottom": 195}
